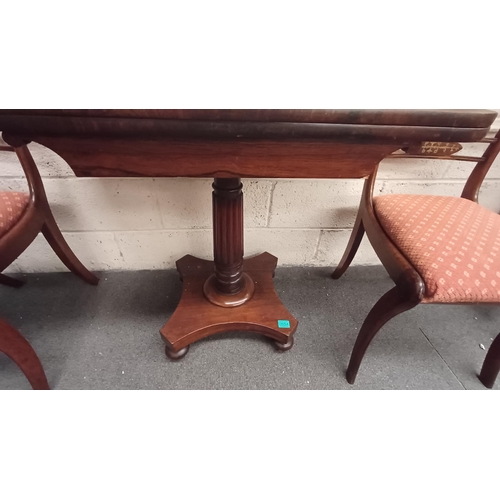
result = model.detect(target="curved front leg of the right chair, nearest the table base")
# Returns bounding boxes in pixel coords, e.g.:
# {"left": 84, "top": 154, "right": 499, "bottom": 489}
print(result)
{"left": 346, "top": 286, "right": 420, "bottom": 384}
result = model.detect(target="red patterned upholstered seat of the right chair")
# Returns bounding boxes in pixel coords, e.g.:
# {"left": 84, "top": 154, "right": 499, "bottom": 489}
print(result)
{"left": 373, "top": 194, "right": 500, "bottom": 303}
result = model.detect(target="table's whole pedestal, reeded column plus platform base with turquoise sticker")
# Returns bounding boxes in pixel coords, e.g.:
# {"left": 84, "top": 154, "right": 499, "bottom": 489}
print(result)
{"left": 160, "top": 178, "right": 298, "bottom": 360}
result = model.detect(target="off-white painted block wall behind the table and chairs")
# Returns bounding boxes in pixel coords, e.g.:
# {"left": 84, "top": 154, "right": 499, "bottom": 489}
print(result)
{"left": 0, "top": 118, "right": 500, "bottom": 272}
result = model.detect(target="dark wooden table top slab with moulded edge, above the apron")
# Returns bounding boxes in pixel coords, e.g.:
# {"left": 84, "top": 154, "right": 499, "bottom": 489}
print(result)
{"left": 0, "top": 109, "right": 497, "bottom": 142}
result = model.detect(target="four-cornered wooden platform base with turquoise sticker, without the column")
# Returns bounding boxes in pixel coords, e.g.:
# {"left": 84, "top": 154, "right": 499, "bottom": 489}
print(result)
{"left": 160, "top": 252, "right": 298, "bottom": 359}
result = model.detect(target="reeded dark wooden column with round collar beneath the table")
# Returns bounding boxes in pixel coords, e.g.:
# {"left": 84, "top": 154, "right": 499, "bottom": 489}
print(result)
{"left": 203, "top": 178, "right": 255, "bottom": 307}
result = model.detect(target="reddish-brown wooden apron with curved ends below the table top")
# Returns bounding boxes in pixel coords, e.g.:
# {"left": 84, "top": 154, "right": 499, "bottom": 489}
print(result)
{"left": 21, "top": 136, "right": 403, "bottom": 179}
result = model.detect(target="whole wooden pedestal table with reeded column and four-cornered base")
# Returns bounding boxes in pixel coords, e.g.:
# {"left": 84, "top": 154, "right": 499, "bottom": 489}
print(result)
{"left": 0, "top": 110, "right": 496, "bottom": 359}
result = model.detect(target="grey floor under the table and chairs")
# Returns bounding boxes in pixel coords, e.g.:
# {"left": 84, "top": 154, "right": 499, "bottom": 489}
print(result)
{"left": 0, "top": 267, "right": 500, "bottom": 389}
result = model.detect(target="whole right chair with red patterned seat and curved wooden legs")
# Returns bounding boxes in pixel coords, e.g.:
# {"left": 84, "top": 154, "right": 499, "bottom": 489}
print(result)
{"left": 332, "top": 127, "right": 500, "bottom": 388}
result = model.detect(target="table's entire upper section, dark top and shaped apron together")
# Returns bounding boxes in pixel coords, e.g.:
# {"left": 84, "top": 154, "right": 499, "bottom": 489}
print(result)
{"left": 0, "top": 109, "right": 497, "bottom": 179}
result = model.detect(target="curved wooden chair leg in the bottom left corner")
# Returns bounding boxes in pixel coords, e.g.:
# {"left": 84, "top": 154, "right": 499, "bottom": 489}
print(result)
{"left": 0, "top": 319, "right": 50, "bottom": 390}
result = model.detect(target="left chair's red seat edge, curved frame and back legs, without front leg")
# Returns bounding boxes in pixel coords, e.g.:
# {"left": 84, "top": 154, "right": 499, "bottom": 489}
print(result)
{"left": 0, "top": 139, "right": 99, "bottom": 287}
